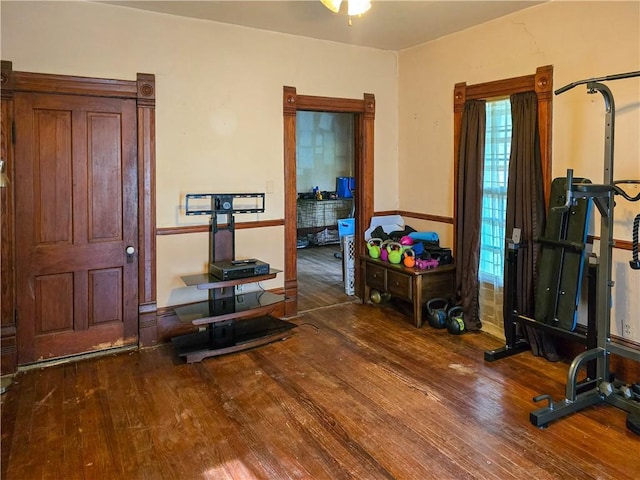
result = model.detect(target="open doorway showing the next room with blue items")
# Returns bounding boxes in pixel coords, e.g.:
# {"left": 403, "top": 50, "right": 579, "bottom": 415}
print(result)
{"left": 296, "top": 110, "right": 355, "bottom": 312}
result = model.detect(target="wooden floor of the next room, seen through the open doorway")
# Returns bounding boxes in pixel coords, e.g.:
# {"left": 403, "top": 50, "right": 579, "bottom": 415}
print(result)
{"left": 298, "top": 245, "right": 358, "bottom": 312}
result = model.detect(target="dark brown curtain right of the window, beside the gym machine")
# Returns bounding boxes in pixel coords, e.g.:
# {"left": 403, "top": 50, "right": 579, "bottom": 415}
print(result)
{"left": 504, "top": 92, "right": 557, "bottom": 360}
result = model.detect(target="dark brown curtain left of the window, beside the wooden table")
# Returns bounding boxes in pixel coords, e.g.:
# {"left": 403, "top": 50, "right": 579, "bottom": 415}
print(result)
{"left": 456, "top": 100, "right": 486, "bottom": 330}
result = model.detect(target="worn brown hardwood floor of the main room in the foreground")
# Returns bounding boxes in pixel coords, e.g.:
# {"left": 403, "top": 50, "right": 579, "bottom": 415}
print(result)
{"left": 1, "top": 303, "right": 640, "bottom": 480}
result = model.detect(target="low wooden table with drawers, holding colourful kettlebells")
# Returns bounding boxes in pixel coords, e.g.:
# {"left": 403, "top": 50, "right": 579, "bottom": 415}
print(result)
{"left": 360, "top": 255, "right": 456, "bottom": 328}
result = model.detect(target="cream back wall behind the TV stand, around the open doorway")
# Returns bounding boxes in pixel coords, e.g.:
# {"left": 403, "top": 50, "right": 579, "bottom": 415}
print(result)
{"left": 1, "top": 0, "right": 398, "bottom": 306}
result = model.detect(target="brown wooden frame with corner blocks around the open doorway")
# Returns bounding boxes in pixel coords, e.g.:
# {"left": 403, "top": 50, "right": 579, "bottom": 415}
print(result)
{"left": 282, "top": 86, "right": 376, "bottom": 317}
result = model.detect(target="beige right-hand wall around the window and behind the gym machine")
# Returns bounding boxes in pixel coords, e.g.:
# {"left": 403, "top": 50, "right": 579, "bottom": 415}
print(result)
{"left": 398, "top": 1, "right": 640, "bottom": 341}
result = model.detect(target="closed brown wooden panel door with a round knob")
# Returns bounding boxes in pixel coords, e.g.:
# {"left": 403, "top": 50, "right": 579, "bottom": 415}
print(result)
{"left": 14, "top": 93, "right": 138, "bottom": 364}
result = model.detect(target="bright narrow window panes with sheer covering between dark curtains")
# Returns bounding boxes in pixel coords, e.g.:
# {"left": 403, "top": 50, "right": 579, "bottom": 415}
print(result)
{"left": 479, "top": 99, "right": 511, "bottom": 286}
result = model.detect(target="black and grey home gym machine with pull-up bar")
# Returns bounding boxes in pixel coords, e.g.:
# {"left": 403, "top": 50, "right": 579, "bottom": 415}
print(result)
{"left": 485, "top": 71, "right": 640, "bottom": 435}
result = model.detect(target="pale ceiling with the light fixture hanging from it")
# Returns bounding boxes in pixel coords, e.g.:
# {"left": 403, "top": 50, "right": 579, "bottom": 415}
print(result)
{"left": 102, "top": 0, "right": 544, "bottom": 50}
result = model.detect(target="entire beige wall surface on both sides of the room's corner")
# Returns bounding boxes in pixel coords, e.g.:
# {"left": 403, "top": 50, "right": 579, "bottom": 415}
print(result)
{"left": 0, "top": 0, "right": 640, "bottom": 340}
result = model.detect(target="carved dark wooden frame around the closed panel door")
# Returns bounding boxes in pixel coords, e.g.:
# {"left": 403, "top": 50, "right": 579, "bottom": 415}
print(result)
{"left": 0, "top": 60, "right": 157, "bottom": 375}
